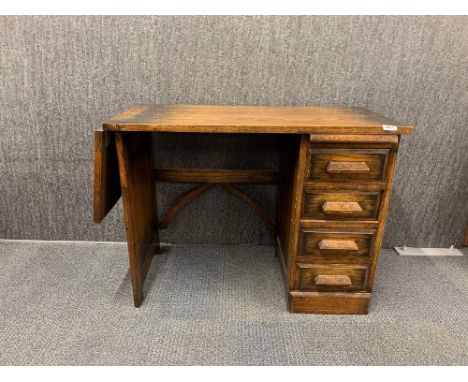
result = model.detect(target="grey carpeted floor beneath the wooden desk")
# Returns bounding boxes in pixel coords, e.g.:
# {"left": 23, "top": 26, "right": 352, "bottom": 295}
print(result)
{"left": 0, "top": 241, "right": 468, "bottom": 365}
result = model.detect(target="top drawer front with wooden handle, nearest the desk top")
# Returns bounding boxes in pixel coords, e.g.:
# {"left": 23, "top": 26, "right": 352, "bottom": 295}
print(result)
{"left": 307, "top": 148, "right": 390, "bottom": 182}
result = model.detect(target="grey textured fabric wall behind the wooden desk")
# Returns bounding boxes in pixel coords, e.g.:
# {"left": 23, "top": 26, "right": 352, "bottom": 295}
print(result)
{"left": 0, "top": 16, "right": 468, "bottom": 246}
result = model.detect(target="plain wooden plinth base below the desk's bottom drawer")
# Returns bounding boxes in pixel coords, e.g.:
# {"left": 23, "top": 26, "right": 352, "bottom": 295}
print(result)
{"left": 288, "top": 291, "right": 370, "bottom": 314}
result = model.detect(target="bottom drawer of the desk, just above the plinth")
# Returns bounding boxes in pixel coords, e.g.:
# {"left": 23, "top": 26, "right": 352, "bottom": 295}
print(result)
{"left": 296, "top": 263, "right": 368, "bottom": 291}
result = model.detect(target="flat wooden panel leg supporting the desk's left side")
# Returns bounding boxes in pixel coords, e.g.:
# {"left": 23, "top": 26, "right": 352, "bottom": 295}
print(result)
{"left": 115, "top": 132, "right": 159, "bottom": 307}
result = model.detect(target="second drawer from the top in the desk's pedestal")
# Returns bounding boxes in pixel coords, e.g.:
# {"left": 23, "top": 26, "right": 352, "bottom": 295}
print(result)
{"left": 302, "top": 190, "right": 381, "bottom": 220}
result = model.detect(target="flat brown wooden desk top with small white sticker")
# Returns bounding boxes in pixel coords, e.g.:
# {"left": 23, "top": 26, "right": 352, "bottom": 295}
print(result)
{"left": 103, "top": 104, "right": 413, "bottom": 134}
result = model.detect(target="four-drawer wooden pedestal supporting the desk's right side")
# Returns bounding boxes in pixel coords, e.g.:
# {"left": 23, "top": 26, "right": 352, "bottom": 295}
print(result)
{"left": 277, "top": 134, "right": 399, "bottom": 314}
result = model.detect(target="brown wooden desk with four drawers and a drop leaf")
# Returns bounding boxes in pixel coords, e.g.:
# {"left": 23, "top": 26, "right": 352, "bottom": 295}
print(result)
{"left": 94, "top": 105, "right": 413, "bottom": 314}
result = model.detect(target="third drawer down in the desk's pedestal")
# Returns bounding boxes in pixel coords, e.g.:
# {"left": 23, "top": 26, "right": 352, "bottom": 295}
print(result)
{"left": 297, "top": 229, "right": 375, "bottom": 263}
